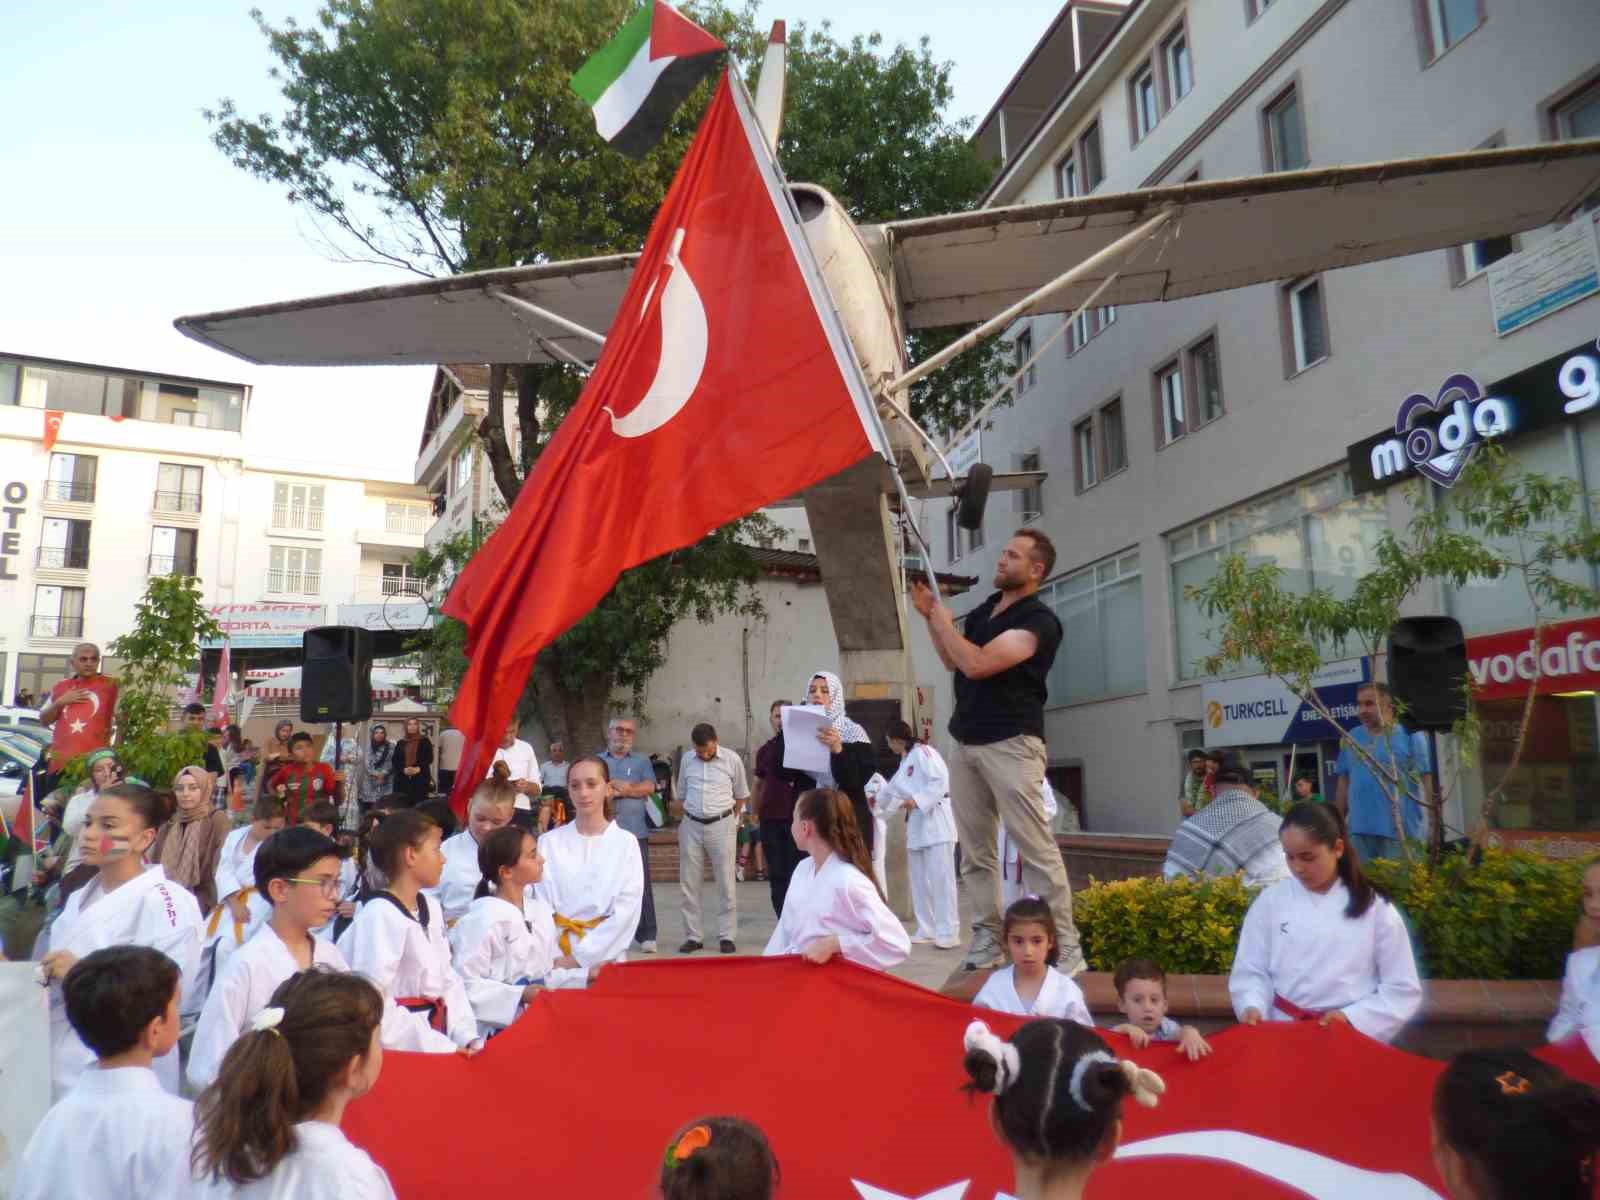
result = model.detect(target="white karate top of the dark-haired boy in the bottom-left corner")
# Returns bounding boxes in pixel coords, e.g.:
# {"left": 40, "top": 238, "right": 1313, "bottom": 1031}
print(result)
{"left": 11, "top": 1054, "right": 194, "bottom": 1200}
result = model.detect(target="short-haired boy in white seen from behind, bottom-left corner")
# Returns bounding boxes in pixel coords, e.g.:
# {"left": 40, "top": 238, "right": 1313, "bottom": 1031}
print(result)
{"left": 11, "top": 946, "right": 194, "bottom": 1200}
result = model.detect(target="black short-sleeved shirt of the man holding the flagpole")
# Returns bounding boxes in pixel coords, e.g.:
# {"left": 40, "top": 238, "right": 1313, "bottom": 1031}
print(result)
{"left": 950, "top": 592, "right": 1061, "bottom": 746}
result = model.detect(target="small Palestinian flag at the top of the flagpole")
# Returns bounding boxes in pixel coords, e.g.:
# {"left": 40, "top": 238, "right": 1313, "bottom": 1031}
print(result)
{"left": 573, "top": 0, "right": 728, "bottom": 158}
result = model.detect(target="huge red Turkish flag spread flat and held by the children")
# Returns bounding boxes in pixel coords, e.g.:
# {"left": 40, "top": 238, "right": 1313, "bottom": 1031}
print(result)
{"left": 344, "top": 958, "right": 1472, "bottom": 1200}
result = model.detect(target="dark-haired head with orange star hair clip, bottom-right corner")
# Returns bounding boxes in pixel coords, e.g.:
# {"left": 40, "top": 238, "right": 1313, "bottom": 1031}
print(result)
{"left": 1432, "top": 1050, "right": 1600, "bottom": 1200}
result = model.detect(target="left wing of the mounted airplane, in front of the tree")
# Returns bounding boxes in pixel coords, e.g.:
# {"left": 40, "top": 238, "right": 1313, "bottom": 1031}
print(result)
{"left": 173, "top": 254, "right": 638, "bottom": 366}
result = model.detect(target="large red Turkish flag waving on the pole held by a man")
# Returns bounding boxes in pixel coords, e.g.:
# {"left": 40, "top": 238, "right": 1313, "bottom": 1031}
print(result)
{"left": 443, "top": 74, "right": 878, "bottom": 813}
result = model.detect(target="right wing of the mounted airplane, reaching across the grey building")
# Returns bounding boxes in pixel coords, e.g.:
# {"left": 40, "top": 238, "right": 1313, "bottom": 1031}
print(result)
{"left": 882, "top": 139, "right": 1600, "bottom": 328}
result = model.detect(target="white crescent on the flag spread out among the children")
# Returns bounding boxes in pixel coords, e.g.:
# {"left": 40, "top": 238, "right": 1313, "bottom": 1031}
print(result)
{"left": 1117, "top": 1130, "right": 1443, "bottom": 1200}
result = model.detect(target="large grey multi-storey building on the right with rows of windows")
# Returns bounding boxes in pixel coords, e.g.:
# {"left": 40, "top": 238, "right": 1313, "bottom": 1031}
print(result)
{"left": 918, "top": 0, "right": 1600, "bottom": 835}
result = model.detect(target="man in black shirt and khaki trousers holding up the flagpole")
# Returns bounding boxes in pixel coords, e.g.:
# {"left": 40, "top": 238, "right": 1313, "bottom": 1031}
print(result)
{"left": 912, "top": 530, "right": 1085, "bottom": 974}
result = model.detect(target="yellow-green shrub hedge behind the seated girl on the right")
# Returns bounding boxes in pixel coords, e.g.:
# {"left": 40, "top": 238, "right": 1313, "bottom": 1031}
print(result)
{"left": 1072, "top": 850, "right": 1584, "bottom": 979}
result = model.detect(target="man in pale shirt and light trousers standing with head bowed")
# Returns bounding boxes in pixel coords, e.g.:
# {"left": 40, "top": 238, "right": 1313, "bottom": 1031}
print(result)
{"left": 678, "top": 723, "right": 750, "bottom": 954}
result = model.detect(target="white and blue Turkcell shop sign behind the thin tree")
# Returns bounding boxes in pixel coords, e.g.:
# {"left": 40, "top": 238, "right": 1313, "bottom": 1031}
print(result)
{"left": 1200, "top": 658, "right": 1370, "bottom": 746}
